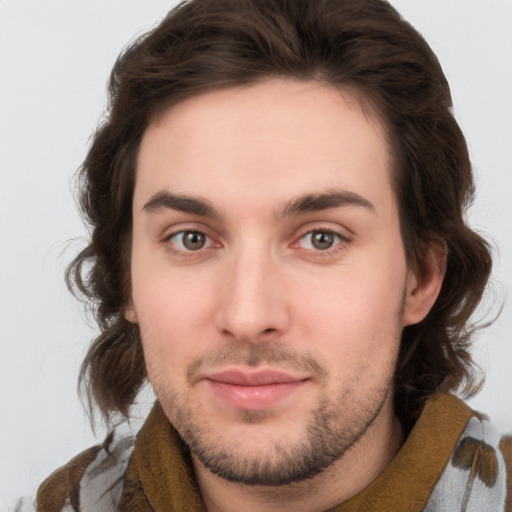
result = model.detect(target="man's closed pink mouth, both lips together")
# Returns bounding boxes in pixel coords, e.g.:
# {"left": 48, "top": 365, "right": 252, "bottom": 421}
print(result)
{"left": 204, "top": 369, "right": 309, "bottom": 411}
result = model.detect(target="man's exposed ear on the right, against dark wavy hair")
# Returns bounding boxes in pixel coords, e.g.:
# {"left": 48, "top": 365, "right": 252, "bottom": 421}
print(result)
{"left": 404, "top": 242, "right": 447, "bottom": 325}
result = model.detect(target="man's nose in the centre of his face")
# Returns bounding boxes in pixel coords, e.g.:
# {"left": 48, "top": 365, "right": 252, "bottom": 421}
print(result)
{"left": 216, "top": 245, "right": 290, "bottom": 343}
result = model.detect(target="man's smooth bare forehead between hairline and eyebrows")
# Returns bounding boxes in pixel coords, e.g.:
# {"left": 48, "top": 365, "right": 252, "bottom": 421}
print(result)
{"left": 134, "top": 79, "right": 390, "bottom": 214}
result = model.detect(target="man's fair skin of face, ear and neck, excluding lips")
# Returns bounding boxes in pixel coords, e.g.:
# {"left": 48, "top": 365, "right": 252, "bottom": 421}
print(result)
{"left": 125, "top": 79, "right": 443, "bottom": 512}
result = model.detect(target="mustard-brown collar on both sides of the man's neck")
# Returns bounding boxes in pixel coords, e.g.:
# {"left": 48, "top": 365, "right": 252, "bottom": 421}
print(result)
{"left": 120, "top": 393, "right": 473, "bottom": 512}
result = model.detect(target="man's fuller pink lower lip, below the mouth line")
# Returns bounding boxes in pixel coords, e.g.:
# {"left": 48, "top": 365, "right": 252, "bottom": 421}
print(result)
{"left": 208, "top": 380, "right": 306, "bottom": 411}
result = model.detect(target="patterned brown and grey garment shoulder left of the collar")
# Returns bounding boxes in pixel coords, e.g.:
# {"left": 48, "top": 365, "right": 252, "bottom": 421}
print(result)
{"left": 36, "top": 431, "right": 134, "bottom": 512}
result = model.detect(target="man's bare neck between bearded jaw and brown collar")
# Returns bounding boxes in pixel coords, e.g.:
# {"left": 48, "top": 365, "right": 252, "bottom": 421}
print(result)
{"left": 193, "top": 401, "right": 403, "bottom": 512}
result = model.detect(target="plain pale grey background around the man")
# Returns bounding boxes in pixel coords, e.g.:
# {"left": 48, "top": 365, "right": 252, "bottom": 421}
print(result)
{"left": 0, "top": 0, "right": 512, "bottom": 511}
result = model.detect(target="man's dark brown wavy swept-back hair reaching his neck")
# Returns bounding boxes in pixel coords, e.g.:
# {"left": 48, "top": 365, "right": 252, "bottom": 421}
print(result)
{"left": 66, "top": 0, "right": 491, "bottom": 425}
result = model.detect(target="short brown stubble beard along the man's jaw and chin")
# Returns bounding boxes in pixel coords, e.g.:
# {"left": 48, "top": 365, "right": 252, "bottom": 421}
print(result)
{"left": 157, "top": 345, "right": 394, "bottom": 486}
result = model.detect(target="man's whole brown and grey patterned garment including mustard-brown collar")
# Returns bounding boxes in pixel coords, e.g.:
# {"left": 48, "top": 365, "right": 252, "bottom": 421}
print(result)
{"left": 36, "top": 393, "right": 512, "bottom": 512}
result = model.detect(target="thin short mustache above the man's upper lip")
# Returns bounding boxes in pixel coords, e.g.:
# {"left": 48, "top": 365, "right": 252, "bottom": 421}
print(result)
{"left": 187, "top": 341, "right": 327, "bottom": 386}
